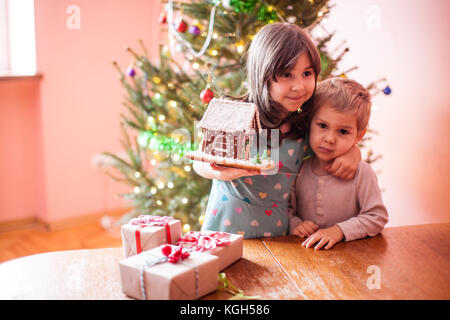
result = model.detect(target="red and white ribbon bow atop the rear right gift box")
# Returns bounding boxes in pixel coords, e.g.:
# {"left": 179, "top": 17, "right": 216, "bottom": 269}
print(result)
{"left": 177, "top": 231, "right": 231, "bottom": 252}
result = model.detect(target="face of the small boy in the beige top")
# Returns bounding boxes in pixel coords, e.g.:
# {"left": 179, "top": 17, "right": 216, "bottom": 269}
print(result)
{"left": 309, "top": 104, "right": 365, "bottom": 161}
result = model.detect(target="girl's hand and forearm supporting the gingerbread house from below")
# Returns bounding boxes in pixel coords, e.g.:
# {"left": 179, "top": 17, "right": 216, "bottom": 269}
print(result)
{"left": 193, "top": 161, "right": 259, "bottom": 181}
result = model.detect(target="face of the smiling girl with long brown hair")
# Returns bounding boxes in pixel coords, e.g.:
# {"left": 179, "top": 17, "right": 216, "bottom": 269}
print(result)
{"left": 269, "top": 53, "right": 316, "bottom": 112}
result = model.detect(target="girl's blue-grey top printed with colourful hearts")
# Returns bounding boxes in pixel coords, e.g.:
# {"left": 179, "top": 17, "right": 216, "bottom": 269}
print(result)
{"left": 202, "top": 138, "right": 310, "bottom": 239}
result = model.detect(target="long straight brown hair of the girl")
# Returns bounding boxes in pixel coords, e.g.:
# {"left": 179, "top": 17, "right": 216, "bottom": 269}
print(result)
{"left": 239, "top": 23, "right": 321, "bottom": 139}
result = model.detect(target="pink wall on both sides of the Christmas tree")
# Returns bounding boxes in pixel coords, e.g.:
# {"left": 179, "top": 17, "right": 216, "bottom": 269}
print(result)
{"left": 0, "top": 0, "right": 450, "bottom": 226}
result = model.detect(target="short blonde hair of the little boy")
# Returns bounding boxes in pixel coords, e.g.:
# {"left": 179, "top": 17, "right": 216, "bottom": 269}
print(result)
{"left": 311, "top": 77, "right": 372, "bottom": 134}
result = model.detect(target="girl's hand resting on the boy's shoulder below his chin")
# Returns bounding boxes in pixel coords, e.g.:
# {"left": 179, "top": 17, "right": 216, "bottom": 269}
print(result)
{"left": 325, "top": 146, "right": 361, "bottom": 180}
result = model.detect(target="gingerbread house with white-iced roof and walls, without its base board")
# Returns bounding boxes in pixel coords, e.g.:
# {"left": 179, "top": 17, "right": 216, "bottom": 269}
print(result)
{"left": 198, "top": 99, "right": 261, "bottom": 160}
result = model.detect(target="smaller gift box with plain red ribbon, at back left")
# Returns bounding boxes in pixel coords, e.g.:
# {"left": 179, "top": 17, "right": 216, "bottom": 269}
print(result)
{"left": 121, "top": 215, "right": 181, "bottom": 257}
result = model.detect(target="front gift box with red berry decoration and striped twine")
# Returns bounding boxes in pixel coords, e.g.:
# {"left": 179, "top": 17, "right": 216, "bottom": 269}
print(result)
{"left": 119, "top": 245, "right": 219, "bottom": 300}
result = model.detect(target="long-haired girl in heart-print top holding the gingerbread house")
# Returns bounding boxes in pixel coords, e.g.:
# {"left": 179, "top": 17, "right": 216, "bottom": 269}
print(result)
{"left": 193, "top": 23, "right": 361, "bottom": 238}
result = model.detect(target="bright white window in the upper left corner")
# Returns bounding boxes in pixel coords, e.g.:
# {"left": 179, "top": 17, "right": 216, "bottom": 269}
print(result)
{"left": 0, "top": 0, "right": 36, "bottom": 76}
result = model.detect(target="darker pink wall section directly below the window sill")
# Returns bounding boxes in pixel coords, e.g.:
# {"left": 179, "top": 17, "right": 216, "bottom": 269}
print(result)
{"left": 0, "top": 78, "right": 45, "bottom": 221}
